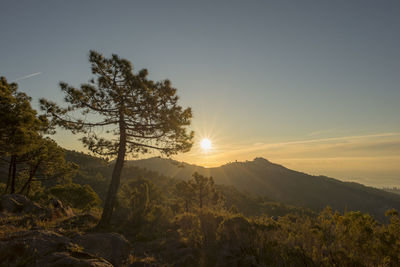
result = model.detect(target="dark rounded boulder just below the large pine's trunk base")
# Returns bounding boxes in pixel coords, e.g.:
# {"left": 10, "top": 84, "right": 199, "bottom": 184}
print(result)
{"left": 72, "top": 233, "right": 130, "bottom": 266}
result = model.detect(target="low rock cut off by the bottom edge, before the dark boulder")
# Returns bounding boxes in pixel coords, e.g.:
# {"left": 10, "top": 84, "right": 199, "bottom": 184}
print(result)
{"left": 37, "top": 252, "right": 113, "bottom": 267}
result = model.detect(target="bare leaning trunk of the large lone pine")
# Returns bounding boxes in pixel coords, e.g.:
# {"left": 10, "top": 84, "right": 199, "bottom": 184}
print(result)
{"left": 97, "top": 114, "right": 126, "bottom": 229}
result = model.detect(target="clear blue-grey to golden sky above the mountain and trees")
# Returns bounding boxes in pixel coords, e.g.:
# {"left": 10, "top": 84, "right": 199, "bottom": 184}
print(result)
{"left": 0, "top": 0, "right": 400, "bottom": 187}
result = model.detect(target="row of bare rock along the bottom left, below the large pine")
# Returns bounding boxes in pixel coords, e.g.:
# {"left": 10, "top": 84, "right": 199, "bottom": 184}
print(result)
{"left": 0, "top": 230, "right": 126, "bottom": 267}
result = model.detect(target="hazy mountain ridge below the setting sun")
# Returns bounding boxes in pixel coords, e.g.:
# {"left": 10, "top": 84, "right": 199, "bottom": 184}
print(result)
{"left": 127, "top": 158, "right": 400, "bottom": 219}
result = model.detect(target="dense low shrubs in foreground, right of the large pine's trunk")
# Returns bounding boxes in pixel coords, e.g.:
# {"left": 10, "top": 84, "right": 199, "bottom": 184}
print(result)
{"left": 108, "top": 171, "right": 400, "bottom": 266}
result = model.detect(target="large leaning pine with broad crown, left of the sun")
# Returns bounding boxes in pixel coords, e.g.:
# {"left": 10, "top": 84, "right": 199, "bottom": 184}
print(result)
{"left": 40, "top": 51, "right": 193, "bottom": 227}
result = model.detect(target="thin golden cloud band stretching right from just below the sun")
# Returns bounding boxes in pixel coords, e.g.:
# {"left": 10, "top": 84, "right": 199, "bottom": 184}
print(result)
{"left": 177, "top": 132, "right": 400, "bottom": 166}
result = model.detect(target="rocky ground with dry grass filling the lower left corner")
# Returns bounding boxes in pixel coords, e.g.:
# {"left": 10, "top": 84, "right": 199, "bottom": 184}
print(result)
{"left": 0, "top": 194, "right": 134, "bottom": 267}
